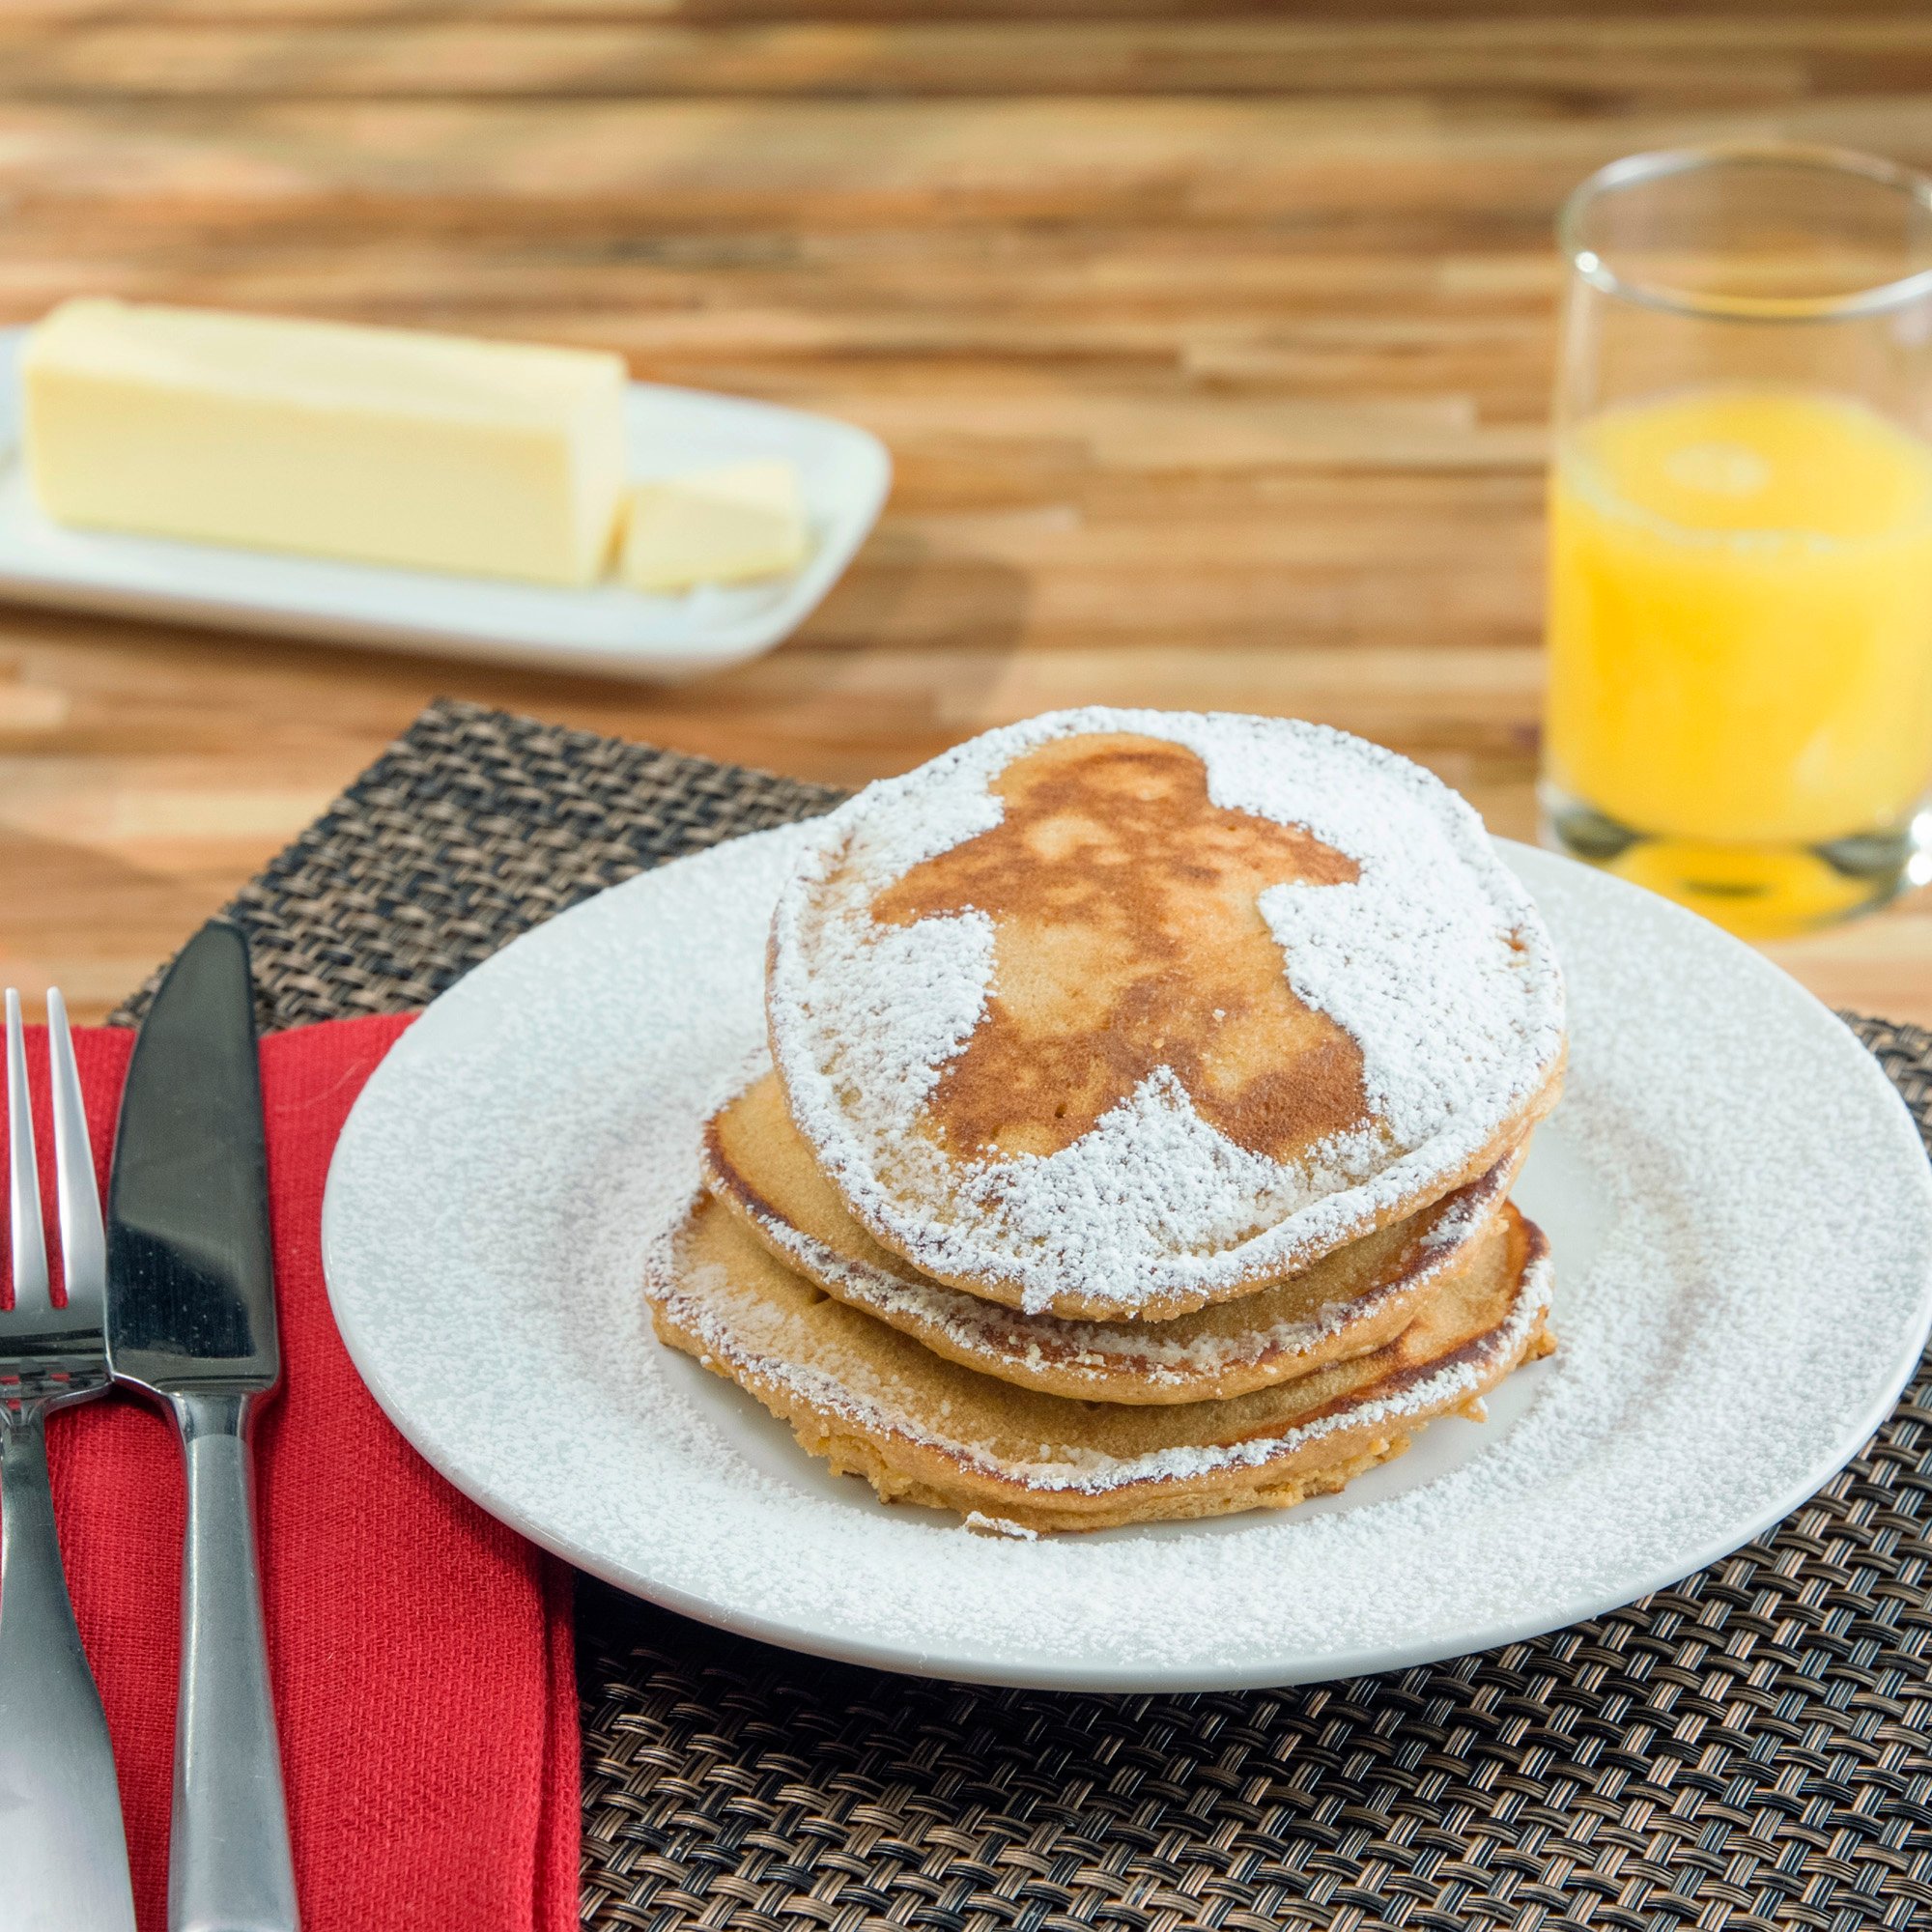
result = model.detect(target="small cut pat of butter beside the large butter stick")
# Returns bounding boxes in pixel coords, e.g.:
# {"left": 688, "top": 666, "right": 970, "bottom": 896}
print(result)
{"left": 624, "top": 458, "right": 811, "bottom": 591}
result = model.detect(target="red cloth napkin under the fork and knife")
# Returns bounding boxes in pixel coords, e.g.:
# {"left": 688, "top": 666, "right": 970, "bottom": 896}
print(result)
{"left": 0, "top": 1018, "right": 578, "bottom": 1932}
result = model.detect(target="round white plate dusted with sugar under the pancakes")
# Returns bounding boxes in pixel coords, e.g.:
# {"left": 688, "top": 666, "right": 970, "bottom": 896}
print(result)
{"left": 323, "top": 827, "right": 1932, "bottom": 1690}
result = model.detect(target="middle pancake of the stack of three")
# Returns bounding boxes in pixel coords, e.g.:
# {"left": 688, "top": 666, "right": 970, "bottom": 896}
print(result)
{"left": 705, "top": 1074, "right": 1522, "bottom": 1403}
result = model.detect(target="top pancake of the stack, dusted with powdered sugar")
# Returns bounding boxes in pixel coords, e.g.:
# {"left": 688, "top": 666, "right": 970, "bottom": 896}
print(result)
{"left": 767, "top": 709, "right": 1563, "bottom": 1321}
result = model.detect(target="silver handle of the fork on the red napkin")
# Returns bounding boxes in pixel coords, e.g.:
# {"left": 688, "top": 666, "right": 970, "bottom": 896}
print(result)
{"left": 0, "top": 1408, "right": 133, "bottom": 1932}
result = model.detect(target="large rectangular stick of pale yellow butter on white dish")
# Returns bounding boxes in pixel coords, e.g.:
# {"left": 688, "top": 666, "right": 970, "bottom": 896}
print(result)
{"left": 21, "top": 299, "right": 626, "bottom": 583}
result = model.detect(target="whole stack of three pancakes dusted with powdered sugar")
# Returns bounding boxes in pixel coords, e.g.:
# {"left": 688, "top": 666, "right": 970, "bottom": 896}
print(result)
{"left": 647, "top": 709, "right": 1565, "bottom": 1532}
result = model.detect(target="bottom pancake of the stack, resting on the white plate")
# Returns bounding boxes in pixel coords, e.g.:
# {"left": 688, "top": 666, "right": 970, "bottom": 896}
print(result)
{"left": 645, "top": 1196, "right": 1549, "bottom": 1532}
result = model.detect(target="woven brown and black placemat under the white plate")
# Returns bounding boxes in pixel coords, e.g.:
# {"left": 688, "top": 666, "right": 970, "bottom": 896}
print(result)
{"left": 122, "top": 703, "right": 1932, "bottom": 1932}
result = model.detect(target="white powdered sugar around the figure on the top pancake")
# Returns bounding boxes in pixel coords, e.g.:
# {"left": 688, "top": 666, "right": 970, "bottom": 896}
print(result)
{"left": 767, "top": 707, "right": 1563, "bottom": 1312}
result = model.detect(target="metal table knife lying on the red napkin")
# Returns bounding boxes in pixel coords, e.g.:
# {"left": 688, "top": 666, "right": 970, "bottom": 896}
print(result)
{"left": 108, "top": 920, "right": 298, "bottom": 1932}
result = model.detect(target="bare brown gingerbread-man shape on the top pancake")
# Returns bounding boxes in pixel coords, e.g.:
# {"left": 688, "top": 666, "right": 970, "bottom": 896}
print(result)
{"left": 871, "top": 732, "right": 1368, "bottom": 1161}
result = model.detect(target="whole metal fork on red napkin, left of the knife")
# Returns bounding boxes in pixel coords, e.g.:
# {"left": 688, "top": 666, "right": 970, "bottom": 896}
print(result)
{"left": 0, "top": 987, "right": 133, "bottom": 1932}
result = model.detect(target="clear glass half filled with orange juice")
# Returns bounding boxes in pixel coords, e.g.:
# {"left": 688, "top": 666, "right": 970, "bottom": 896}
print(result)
{"left": 1542, "top": 143, "right": 1932, "bottom": 937}
